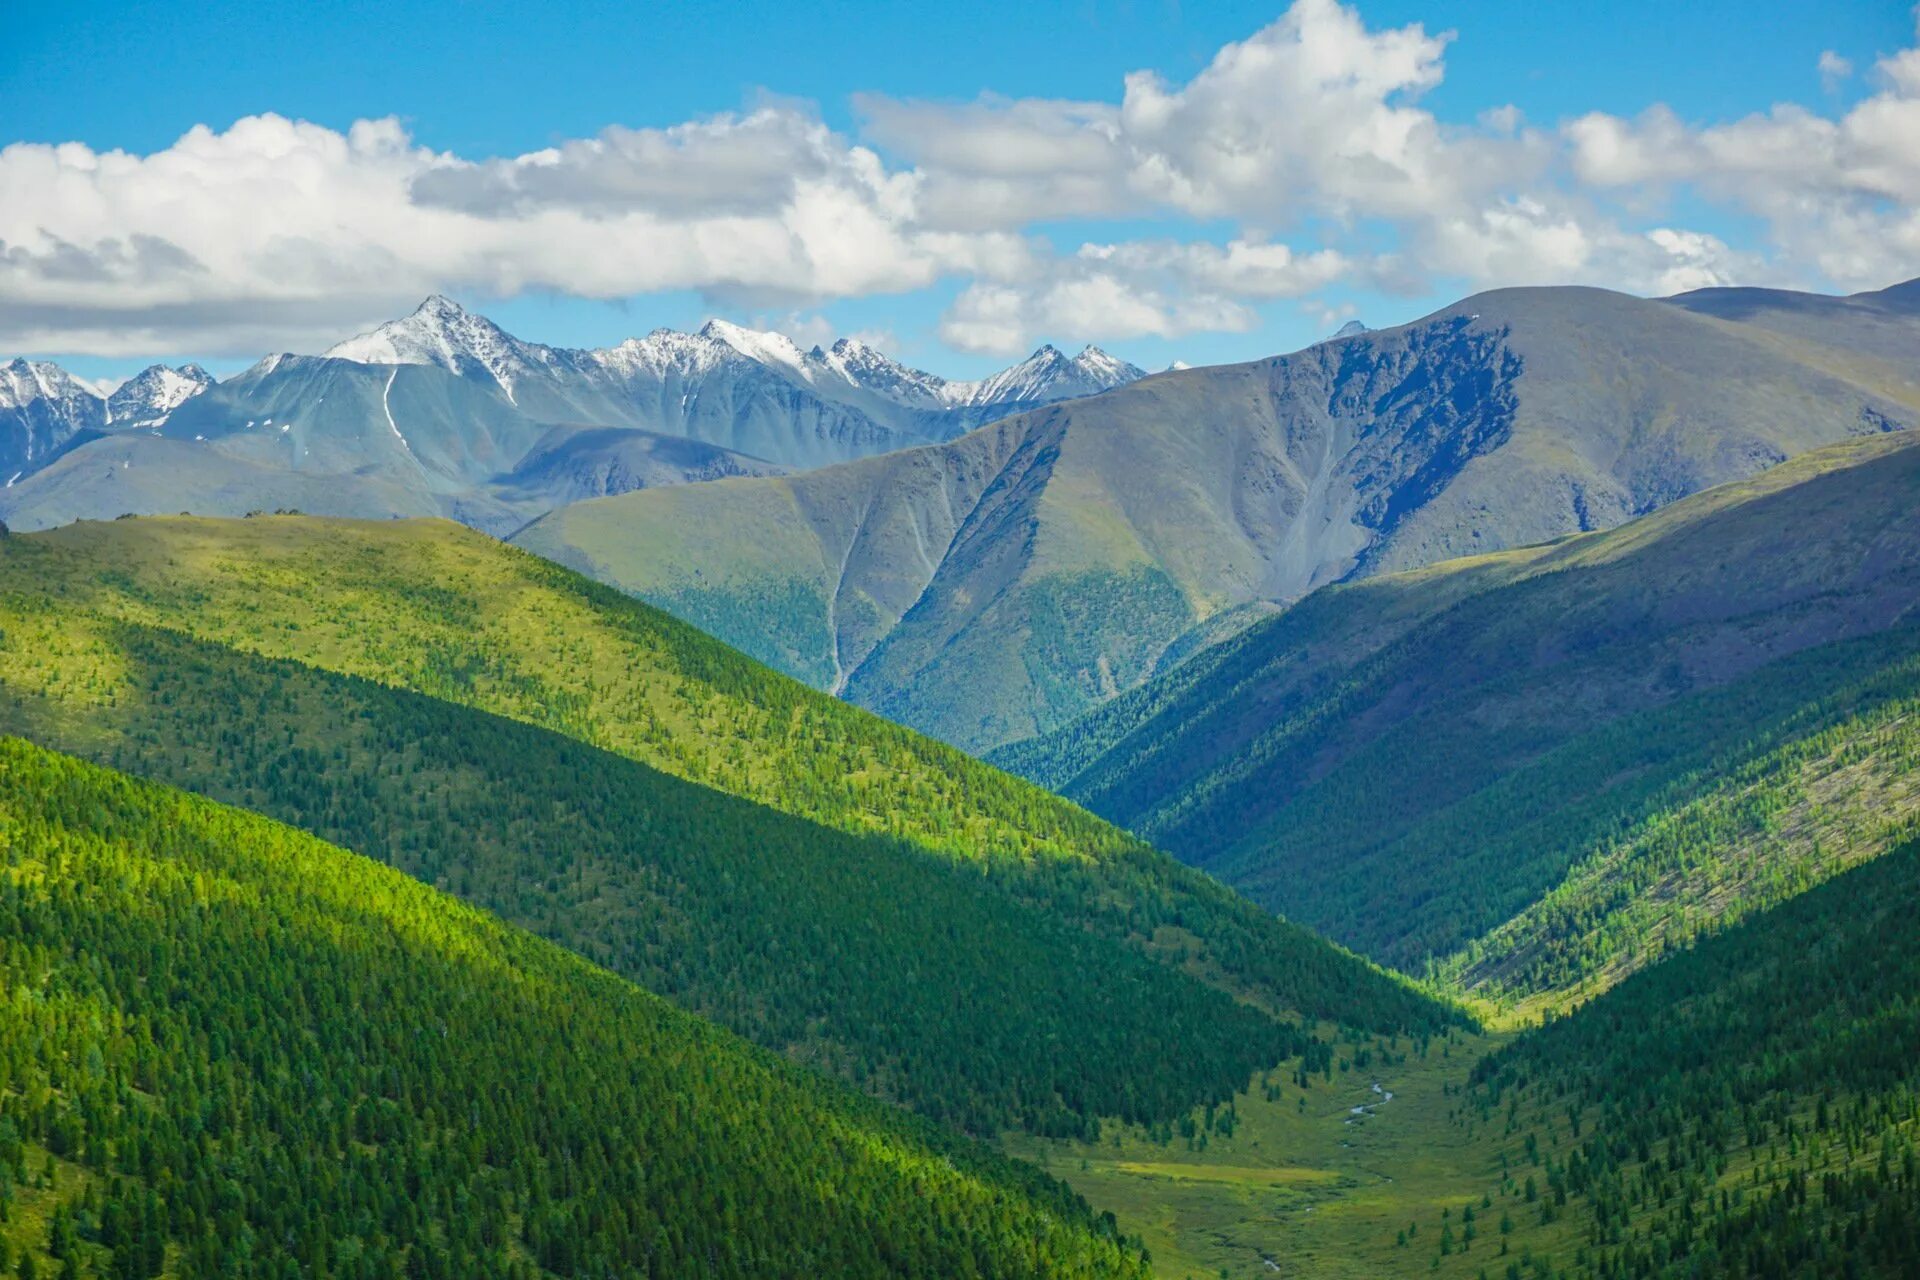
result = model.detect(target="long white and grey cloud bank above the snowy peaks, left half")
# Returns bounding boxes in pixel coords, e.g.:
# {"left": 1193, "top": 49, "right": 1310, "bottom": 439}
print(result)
{"left": 0, "top": 107, "right": 967, "bottom": 351}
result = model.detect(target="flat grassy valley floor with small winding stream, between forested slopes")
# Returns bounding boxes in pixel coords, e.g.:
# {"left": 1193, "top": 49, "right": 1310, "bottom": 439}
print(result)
{"left": 1004, "top": 1032, "right": 1586, "bottom": 1280}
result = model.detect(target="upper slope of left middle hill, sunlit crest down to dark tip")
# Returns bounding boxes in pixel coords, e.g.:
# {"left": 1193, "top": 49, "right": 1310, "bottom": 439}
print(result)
{"left": 0, "top": 518, "right": 1457, "bottom": 1029}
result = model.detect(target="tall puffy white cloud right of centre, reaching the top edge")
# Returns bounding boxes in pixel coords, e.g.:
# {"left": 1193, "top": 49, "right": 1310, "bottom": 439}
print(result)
{"left": 856, "top": 0, "right": 1544, "bottom": 226}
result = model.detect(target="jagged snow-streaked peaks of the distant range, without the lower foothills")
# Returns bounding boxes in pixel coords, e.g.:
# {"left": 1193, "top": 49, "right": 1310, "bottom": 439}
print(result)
{"left": 0, "top": 294, "right": 1142, "bottom": 518}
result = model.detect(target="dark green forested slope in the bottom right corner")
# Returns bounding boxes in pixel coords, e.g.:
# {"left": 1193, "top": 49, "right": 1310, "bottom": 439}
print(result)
{"left": 1473, "top": 844, "right": 1920, "bottom": 1280}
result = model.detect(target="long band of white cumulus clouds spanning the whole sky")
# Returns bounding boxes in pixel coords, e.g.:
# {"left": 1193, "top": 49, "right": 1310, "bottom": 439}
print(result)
{"left": 0, "top": 0, "right": 1920, "bottom": 355}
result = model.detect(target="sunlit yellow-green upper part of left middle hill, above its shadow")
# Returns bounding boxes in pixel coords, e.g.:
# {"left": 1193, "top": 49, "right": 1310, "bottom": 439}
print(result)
{"left": 22, "top": 516, "right": 1131, "bottom": 858}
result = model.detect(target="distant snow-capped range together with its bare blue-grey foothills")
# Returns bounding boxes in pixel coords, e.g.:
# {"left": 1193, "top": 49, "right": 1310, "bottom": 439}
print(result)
{"left": 0, "top": 296, "right": 1140, "bottom": 533}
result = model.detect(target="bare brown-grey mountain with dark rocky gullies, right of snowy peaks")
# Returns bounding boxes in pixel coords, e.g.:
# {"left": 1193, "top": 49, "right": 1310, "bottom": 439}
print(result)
{"left": 516, "top": 276, "right": 1920, "bottom": 750}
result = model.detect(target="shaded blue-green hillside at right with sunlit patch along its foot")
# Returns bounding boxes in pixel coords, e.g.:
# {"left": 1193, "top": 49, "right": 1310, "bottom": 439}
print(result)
{"left": 998, "top": 434, "right": 1920, "bottom": 1004}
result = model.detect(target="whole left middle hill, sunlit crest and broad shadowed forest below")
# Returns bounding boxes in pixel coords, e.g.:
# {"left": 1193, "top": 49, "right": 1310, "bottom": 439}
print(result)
{"left": 0, "top": 518, "right": 1457, "bottom": 1134}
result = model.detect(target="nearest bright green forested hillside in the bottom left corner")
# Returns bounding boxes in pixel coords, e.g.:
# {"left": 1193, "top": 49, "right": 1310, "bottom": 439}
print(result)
{"left": 0, "top": 739, "right": 1144, "bottom": 1280}
